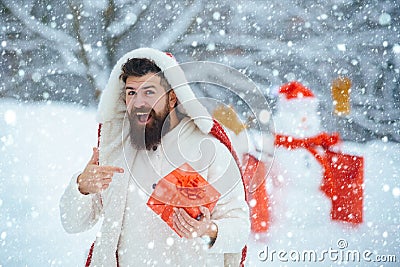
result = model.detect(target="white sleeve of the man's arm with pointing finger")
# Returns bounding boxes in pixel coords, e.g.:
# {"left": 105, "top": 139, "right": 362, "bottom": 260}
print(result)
{"left": 60, "top": 173, "right": 103, "bottom": 233}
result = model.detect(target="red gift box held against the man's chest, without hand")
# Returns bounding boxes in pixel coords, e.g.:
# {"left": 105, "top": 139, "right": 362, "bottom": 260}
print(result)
{"left": 147, "top": 163, "right": 221, "bottom": 235}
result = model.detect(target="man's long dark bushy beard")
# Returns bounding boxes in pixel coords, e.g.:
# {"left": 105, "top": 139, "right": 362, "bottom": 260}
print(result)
{"left": 128, "top": 105, "right": 170, "bottom": 150}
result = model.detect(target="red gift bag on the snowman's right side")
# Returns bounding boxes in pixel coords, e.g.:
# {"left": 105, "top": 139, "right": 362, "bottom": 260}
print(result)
{"left": 321, "top": 150, "right": 364, "bottom": 224}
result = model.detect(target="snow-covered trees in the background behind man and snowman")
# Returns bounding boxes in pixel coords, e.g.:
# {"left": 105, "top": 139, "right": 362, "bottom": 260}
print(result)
{"left": 0, "top": 0, "right": 400, "bottom": 141}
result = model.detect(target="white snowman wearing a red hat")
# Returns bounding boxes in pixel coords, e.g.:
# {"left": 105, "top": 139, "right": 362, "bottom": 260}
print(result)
{"left": 268, "top": 82, "right": 331, "bottom": 253}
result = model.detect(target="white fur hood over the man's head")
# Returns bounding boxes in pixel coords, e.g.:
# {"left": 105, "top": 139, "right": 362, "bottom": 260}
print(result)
{"left": 97, "top": 48, "right": 213, "bottom": 164}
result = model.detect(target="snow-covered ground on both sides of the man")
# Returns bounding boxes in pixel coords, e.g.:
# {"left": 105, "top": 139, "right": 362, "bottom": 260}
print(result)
{"left": 0, "top": 100, "right": 400, "bottom": 266}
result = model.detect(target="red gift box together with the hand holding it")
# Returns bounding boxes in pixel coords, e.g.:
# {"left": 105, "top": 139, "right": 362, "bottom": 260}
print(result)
{"left": 147, "top": 163, "right": 221, "bottom": 239}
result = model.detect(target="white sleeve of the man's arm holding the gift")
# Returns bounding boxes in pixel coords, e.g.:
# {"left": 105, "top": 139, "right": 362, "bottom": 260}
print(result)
{"left": 208, "top": 141, "right": 250, "bottom": 253}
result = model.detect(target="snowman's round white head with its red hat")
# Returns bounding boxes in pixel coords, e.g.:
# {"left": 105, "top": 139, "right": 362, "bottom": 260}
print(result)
{"left": 274, "top": 81, "right": 321, "bottom": 138}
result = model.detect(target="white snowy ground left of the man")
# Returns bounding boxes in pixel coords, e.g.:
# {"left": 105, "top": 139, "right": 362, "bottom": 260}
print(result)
{"left": 0, "top": 99, "right": 97, "bottom": 266}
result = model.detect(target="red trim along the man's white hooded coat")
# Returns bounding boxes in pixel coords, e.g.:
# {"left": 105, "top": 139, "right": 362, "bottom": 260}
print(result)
{"left": 85, "top": 119, "right": 247, "bottom": 267}
